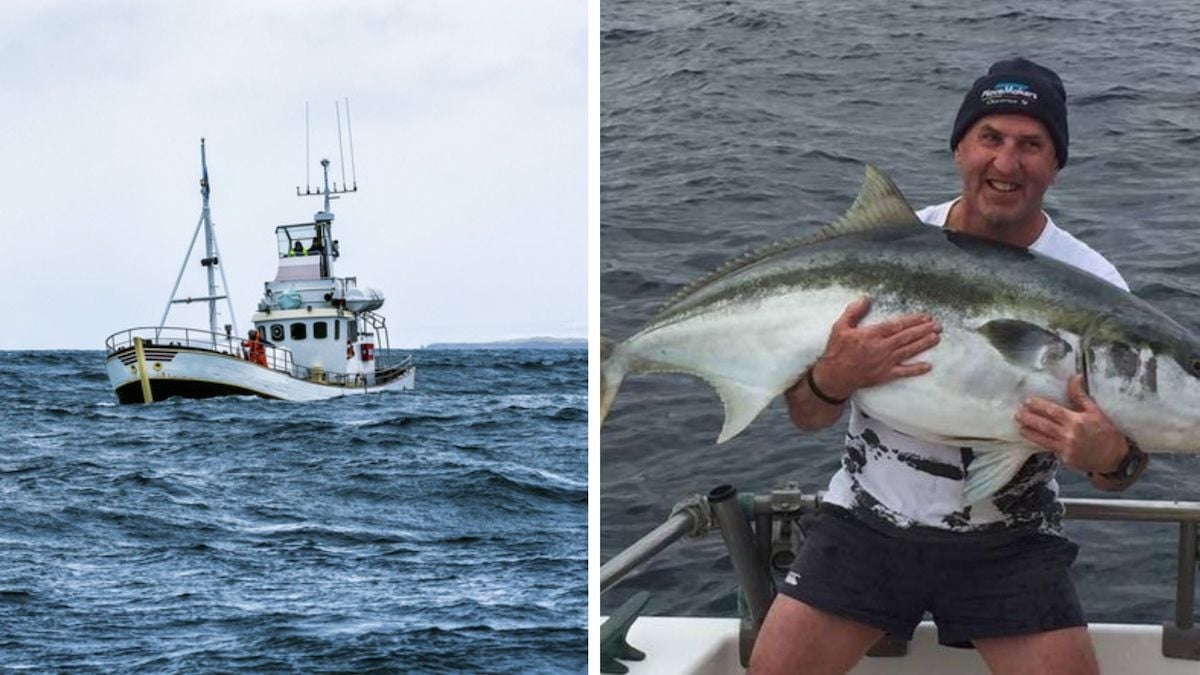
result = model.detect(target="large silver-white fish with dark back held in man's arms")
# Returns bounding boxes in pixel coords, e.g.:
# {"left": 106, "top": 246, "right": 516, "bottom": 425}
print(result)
{"left": 600, "top": 166, "right": 1200, "bottom": 503}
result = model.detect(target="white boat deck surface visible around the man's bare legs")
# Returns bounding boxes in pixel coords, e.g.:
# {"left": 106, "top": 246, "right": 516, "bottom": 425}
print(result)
{"left": 622, "top": 616, "right": 1200, "bottom": 675}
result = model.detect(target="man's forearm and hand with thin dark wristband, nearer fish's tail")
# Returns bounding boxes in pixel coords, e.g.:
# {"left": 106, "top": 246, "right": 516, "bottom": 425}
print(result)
{"left": 784, "top": 297, "right": 942, "bottom": 431}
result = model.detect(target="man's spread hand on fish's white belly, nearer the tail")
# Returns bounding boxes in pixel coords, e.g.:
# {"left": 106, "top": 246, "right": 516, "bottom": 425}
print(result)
{"left": 812, "top": 297, "right": 942, "bottom": 399}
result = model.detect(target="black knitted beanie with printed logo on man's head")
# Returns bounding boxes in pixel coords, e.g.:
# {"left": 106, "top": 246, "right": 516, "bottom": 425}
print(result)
{"left": 950, "top": 58, "right": 1069, "bottom": 168}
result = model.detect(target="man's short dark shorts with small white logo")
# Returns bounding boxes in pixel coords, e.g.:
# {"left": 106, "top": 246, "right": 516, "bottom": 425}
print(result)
{"left": 780, "top": 506, "right": 1087, "bottom": 647}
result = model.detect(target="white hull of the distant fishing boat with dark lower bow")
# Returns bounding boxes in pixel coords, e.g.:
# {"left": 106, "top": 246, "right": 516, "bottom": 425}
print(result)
{"left": 104, "top": 346, "right": 416, "bottom": 404}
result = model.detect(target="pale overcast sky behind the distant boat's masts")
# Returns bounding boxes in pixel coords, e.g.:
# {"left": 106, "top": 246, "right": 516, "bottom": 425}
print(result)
{"left": 0, "top": 0, "right": 587, "bottom": 350}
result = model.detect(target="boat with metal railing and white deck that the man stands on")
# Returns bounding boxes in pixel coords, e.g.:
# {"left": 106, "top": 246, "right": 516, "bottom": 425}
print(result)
{"left": 600, "top": 484, "right": 1200, "bottom": 675}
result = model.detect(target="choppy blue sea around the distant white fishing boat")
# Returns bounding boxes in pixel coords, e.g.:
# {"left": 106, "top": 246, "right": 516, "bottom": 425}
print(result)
{"left": 0, "top": 350, "right": 587, "bottom": 673}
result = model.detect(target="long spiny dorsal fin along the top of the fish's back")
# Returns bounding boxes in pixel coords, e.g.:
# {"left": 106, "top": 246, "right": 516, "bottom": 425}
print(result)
{"left": 658, "top": 165, "right": 923, "bottom": 315}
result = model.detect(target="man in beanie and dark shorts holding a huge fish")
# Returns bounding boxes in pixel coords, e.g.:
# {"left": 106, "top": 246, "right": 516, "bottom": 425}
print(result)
{"left": 750, "top": 58, "right": 1146, "bottom": 675}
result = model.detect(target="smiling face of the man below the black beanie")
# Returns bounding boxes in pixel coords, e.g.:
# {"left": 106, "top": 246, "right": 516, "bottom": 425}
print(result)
{"left": 954, "top": 114, "right": 1058, "bottom": 231}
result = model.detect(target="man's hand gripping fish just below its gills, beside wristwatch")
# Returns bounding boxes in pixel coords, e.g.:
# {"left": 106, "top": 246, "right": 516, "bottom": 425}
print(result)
{"left": 1016, "top": 375, "right": 1129, "bottom": 473}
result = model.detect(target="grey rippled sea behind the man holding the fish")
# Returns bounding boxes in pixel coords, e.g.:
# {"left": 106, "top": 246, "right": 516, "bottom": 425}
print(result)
{"left": 600, "top": 0, "right": 1200, "bottom": 622}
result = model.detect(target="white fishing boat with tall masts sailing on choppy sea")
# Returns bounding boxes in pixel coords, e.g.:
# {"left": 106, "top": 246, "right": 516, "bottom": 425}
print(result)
{"left": 104, "top": 135, "right": 416, "bottom": 404}
